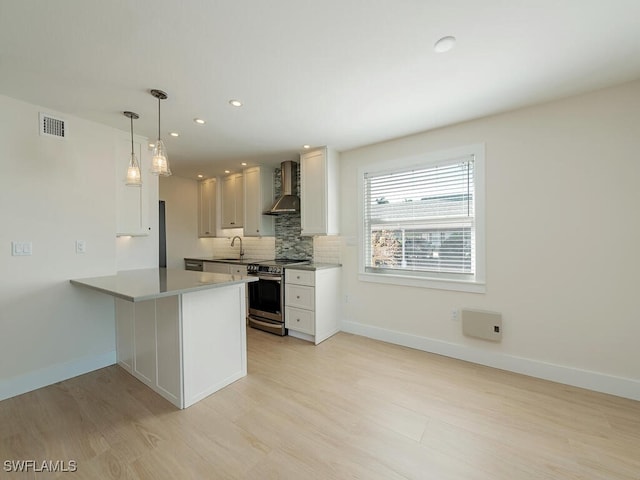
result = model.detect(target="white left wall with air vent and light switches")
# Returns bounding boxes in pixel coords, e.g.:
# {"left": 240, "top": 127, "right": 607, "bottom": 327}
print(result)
{"left": 0, "top": 96, "right": 157, "bottom": 399}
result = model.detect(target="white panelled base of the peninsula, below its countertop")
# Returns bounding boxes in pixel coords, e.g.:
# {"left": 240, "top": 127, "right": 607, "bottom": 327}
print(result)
{"left": 116, "top": 284, "right": 247, "bottom": 408}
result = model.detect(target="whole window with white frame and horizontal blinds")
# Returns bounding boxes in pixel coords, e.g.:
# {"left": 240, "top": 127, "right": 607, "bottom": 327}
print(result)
{"left": 360, "top": 145, "right": 484, "bottom": 291}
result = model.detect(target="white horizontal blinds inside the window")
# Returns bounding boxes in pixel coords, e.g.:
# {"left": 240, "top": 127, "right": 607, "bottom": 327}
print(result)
{"left": 364, "top": 155, "right": 475, "bottom": 278}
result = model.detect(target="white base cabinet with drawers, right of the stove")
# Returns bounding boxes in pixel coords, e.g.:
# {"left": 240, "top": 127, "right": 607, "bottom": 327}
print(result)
{"left": 284, "top": 267, "right": 340, "bottom": 345}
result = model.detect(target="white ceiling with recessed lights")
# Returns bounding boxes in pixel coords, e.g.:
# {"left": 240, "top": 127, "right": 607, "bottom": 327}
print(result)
{"left": 0, "top": 0, "right": 640, "bottom": 177}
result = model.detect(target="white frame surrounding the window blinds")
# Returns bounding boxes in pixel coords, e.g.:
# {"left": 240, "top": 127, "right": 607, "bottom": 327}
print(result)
{"left": 358, "top": 144, "right": 486, "bottom": 293}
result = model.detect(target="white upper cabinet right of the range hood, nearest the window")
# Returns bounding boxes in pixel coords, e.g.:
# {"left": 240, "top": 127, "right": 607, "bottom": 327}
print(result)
{"left": 300, "top": 147, "right": 340, "bottom": 236}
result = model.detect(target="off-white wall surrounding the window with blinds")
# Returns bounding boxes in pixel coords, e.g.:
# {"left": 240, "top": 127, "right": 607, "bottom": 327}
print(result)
{"left": 341, "top": 82, "right": 640, "bottom": 399}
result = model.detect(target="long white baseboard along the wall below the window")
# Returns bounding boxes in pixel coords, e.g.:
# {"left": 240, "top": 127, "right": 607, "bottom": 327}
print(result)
{"left": 341, "top": 320, "right": 640, "bottom": 400}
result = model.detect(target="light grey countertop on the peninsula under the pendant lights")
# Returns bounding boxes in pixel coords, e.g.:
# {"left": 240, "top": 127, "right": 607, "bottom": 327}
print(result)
{"left": 71, "top": 268, "right": 258, "bottom": 302}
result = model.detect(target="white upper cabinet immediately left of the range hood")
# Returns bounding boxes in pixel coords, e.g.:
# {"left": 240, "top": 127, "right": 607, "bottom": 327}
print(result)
{"left": 243, "top": 166, "right": 274, "bottom": 237}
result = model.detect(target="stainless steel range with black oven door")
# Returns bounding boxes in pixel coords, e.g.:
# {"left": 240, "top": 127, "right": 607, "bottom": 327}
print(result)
{"left": 247, "top": 259, "right": 309, "bottom": 336}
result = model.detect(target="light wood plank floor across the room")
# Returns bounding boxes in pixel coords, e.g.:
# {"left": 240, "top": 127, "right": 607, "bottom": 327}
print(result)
{"left": 0, "top": 329, "right": 640, "bottom": 480}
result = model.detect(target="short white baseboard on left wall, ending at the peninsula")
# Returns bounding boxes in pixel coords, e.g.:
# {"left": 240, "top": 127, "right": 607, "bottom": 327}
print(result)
{"left": 0, "top": 350, "right": 116, "bottom": 400}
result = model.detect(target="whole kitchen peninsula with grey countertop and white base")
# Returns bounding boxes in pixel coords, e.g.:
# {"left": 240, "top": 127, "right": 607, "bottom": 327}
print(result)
{"left": 71, "top": 268, "right": 257, "bottom": 408}
